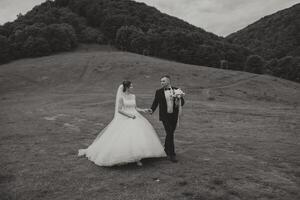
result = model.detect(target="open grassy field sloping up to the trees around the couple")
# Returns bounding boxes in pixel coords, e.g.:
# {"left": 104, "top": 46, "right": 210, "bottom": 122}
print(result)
{"left": 0, "top": 46, "right": 300, "bottom": 200}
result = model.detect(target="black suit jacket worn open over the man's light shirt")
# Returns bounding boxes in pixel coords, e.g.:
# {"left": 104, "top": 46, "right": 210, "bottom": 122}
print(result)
{"left": 151, "top": 87, "right": 184, "bottom": 121}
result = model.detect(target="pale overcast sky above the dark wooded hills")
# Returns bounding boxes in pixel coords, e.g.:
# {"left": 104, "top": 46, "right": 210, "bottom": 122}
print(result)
{"left": 0, "top": 0, "right": 300, "bottom": 36}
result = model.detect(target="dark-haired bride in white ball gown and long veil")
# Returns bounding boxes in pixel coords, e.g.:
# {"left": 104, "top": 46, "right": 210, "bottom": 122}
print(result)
{"left": 78, "top": 81, "right": 166, "bottom": 166}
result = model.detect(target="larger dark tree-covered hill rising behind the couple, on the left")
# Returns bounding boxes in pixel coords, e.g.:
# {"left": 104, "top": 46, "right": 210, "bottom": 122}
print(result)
{"left": 0, "top": 0, "right": 250, "bottom": 70}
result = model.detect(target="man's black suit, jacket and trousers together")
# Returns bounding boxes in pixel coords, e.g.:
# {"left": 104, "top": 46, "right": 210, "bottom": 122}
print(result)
{"left": 151, "top": 87, "right": 184, "bottom": 156}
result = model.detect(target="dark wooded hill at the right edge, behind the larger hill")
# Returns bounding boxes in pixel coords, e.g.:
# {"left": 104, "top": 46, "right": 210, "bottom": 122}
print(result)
{"left": 226, "top": 4, "right": 300, "bottom": 82}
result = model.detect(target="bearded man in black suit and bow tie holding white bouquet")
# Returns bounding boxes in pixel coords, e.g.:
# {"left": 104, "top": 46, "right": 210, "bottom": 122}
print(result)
{"left": 149, "top": 75, "right": 184, "bottom": 162}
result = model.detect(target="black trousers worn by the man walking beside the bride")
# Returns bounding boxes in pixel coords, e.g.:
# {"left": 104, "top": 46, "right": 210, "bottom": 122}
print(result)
{"left": 162, "top": 114, "right": 178, "bottom": 156}
